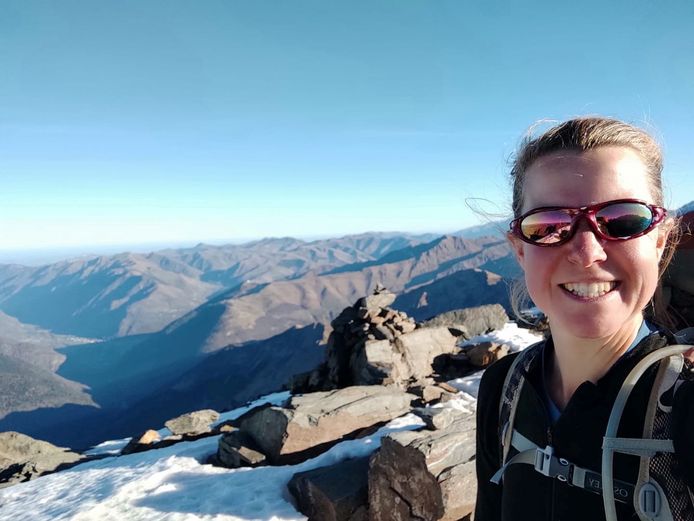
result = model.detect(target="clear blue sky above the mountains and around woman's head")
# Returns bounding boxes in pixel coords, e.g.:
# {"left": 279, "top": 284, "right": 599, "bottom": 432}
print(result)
{"left": 0, "top": 0, "right": 694, "bottom": 256}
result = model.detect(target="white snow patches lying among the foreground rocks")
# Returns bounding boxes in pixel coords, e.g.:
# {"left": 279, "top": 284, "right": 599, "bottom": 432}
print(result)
{"left": 0, "top": 323, "right": 540, "bottom": 521}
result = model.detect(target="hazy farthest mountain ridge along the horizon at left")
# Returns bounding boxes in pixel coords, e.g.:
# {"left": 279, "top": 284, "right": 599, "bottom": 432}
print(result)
{"left": 0, "top": 234, "right": 438, "bottom": 338}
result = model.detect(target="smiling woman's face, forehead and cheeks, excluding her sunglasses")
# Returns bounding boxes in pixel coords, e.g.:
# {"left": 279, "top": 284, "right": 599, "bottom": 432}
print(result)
{"left": 512, "top": 146, "right": 667, "bottom": 339}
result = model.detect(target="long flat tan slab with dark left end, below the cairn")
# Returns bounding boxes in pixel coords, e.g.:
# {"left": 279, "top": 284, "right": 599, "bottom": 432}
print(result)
{"left": 239, "top": 386, "right": 415, "bottom": 463}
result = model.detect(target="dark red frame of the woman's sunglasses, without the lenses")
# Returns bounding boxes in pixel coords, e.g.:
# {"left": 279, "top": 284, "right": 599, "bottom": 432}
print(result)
{"left": 509, "top": 199, "right": 667, "bottom": 247}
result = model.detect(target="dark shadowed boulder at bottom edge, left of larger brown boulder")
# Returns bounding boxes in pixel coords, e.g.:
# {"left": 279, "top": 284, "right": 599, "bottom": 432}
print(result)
{"left": 287, "top": 456, "right": 369, "bottom": 521}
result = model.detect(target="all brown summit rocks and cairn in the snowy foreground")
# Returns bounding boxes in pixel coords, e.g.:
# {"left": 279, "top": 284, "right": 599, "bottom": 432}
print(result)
{"left": 0, "top": 287, "right": 536, "bottom": 521}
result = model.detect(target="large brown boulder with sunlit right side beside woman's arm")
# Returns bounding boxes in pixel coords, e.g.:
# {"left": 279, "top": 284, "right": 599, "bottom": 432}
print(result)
{"left": 369, "top": 413, "right": 477, "bottom": 521}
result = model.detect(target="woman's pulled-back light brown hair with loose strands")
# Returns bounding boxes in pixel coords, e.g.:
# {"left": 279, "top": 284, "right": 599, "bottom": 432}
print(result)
{"left": 511, "top": 116, "right": 679, "bottom": 326}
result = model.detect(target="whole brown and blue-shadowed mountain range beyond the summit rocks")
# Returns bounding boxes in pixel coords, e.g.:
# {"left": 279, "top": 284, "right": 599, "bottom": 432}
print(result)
{"left": 0, "top": 229, "right": 519, "bottom": 447}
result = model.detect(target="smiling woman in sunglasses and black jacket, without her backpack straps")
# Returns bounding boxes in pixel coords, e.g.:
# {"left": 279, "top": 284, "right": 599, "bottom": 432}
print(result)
{"left": 475, "top": 118, "right": 694, "bottom": 521}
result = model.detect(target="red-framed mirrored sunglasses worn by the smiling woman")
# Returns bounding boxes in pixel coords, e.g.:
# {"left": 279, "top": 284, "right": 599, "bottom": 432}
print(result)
{"left": 510, "top": 199, "right": 667, "bottom": 246}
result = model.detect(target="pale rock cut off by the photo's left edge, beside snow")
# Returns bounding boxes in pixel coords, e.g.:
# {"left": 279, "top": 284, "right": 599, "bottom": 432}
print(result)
{"left": 0, "top": 432, "right": 82, "bottom": 488}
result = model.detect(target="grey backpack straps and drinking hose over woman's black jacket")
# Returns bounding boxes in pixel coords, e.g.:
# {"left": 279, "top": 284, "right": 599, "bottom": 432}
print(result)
{"left": 491, "top": 328, "right": 694, "bottom": 521}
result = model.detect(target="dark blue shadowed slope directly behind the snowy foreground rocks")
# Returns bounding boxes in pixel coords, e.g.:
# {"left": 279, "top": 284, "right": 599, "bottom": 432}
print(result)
{"left": 0, "top": 325, "right": 324, "bottom": 449}
